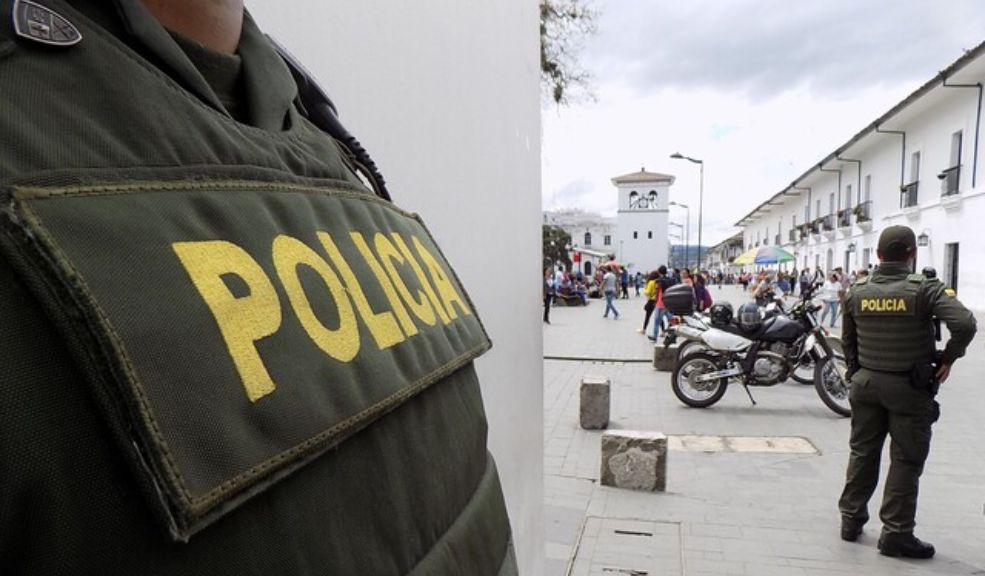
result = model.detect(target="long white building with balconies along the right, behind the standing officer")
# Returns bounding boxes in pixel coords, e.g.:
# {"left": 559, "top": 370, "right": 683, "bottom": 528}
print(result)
{"left": 736, "top": 43, "right": 985, "bottom": 309}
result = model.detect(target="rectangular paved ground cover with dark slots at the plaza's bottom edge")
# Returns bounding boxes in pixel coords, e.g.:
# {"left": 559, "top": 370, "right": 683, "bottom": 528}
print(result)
{"left": 568, "top": 517, "right": 683, "bottom": 576}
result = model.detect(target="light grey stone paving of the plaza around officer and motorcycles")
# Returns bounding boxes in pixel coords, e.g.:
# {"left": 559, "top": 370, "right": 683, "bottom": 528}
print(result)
{"left": 544, "top": 287, "right": 985, "bottom": 576}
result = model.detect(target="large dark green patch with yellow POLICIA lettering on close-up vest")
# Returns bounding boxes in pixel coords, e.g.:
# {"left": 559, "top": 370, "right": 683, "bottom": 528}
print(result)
{"left": 3, "top": 181, "right": 490, "bottom": 539}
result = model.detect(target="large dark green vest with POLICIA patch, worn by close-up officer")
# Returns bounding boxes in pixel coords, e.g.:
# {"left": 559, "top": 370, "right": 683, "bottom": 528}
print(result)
{"left": 0, "top": 0, "right": 516, "bottom": 576}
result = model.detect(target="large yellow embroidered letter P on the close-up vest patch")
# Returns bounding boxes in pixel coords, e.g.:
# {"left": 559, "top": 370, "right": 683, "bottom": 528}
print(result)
{"left": 171, "top": 240, "right": 281, "bottom": 402}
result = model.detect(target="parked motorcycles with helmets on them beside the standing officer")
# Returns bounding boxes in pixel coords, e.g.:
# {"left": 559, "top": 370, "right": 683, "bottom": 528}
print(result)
{"left": 663, "top": 285, "right": 851, "bottom": 416}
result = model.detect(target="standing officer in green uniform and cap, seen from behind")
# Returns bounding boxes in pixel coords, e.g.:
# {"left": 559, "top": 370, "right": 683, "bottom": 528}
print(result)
{"left": 838, "top": 226, "right": 976, "bottom": 558}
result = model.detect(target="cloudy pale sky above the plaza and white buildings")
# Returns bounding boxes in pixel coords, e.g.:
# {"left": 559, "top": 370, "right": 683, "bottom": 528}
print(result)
{"left": 542, "top": 0, "right": 985, "bottom": 245}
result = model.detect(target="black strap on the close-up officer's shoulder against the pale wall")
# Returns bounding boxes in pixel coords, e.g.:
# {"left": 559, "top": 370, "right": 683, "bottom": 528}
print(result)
{"left": 267, "top": 36, "right": 390, "bottom": 201}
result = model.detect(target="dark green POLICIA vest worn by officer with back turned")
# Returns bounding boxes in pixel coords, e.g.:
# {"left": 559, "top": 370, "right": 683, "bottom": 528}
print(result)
{"left": 850, "top": 274, "right": 934, "bottom": 372}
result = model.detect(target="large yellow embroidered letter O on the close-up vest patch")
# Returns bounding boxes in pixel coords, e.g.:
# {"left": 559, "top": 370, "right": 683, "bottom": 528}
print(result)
{"left": 273, "top": 235, "right": 359, "bottom": 362}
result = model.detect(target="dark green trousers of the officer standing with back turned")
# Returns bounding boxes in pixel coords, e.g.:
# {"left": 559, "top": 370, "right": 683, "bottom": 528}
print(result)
{"left": 838, "top": 368, "right": 937, "bottom": 534}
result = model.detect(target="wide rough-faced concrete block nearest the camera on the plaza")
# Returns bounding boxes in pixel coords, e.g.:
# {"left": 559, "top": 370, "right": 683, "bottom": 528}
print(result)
{"left": 600, "top": 430, "right": 667, "bottom": 492}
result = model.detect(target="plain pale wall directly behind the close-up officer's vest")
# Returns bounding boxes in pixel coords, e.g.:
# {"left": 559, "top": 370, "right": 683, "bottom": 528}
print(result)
{"left": 247, "top": 0, "right": 540, "bottom": 575}
